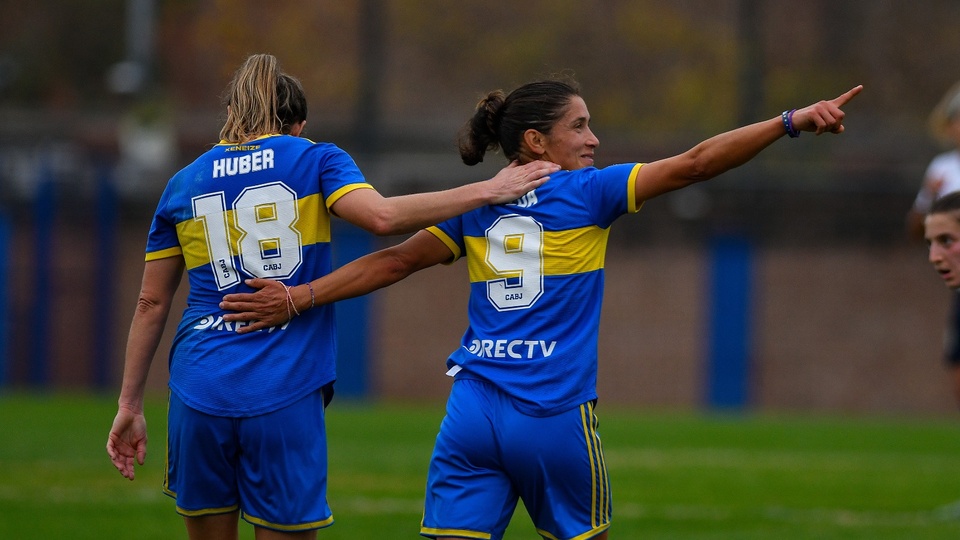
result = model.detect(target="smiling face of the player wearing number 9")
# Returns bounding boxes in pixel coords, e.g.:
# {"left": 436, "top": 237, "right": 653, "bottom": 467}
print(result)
{"left": 537, "top": 96, "right": 600, "bottom": 171}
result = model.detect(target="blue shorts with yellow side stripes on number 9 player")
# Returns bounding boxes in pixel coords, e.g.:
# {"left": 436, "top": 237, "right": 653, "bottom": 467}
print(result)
{"left": 420, "top": 378, "right": 612, "bottom": 540}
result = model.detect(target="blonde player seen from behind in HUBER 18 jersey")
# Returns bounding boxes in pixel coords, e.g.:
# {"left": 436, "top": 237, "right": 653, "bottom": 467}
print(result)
{"left": 106, "top": 55, "right": 557, "bottom": 540}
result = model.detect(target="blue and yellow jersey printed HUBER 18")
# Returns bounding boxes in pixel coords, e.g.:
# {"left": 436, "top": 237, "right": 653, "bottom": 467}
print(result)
{"left": 146, "top": 135, "right": 372, "bottom": 417}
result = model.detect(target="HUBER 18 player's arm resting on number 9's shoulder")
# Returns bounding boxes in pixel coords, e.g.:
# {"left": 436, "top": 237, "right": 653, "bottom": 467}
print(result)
{"left": 332, "top": 161, "right": 560, "bottom": 236}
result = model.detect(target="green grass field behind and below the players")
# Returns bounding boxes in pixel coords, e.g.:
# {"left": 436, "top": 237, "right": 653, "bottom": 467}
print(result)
{"left": 0, "top": 394, "right": 960, "bottom": 540}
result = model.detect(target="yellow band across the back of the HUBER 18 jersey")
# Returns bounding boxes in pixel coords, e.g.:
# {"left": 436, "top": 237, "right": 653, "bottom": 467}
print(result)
{"left": 172, "top": 193, "right": 330, "bottom": 270}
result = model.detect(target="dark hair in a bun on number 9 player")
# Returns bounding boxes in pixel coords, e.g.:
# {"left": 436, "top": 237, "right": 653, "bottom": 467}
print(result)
{"left": 457, "top": 80, "right": 580, "bottom": 165}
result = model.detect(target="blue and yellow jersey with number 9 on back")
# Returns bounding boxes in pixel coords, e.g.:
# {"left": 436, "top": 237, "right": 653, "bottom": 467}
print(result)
{"left": 427, "top": 164, "right": 641, "bottom": 416}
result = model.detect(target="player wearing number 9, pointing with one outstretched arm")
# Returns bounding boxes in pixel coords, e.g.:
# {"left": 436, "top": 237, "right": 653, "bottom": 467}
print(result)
{"left": 221, "top": 80, "right": 862, "bottom": 539}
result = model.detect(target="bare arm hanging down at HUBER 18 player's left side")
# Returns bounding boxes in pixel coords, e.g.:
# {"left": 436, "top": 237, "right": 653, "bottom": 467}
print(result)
{"left": 107, "top": 257, "right": 184, "bottom": 480}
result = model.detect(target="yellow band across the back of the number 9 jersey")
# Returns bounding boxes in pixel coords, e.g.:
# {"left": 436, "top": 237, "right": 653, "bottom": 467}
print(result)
{"left": 464, "top": 225, "right": 610, "bottom": 283}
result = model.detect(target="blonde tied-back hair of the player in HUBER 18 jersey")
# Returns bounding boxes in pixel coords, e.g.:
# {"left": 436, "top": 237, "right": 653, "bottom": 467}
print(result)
{"left": 220, "top": 54, "right": 307, "bottom": 143}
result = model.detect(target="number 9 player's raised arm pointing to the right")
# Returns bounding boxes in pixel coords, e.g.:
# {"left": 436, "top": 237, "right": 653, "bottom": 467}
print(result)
{"left": 635, "top": 85, "right": 863, "bottom": 205}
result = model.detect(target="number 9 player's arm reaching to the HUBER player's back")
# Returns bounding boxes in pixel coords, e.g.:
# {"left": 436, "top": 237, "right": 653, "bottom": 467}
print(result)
{"left": 220, "top": 231, "right": 452, "bottom": 334}
